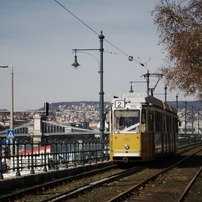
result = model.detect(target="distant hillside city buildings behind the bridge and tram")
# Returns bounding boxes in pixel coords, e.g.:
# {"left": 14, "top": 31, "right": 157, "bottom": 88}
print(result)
{"left": 0, "top": 101, "right": 202, "bottom": 134}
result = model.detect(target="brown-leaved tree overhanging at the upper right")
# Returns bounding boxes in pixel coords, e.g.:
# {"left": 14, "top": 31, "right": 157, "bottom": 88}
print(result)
{"left": 152, "top": 0, "right": 202, "bottom": 100}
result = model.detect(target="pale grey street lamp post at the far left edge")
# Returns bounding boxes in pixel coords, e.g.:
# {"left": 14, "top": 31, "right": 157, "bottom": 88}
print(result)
{"left": 0, "top": 65, "right": 14, "bottom": 155}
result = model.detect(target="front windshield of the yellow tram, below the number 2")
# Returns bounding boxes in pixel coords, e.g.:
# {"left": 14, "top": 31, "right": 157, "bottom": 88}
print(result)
{"left": 113, "top": 110, "right": 140, "bottom": 133}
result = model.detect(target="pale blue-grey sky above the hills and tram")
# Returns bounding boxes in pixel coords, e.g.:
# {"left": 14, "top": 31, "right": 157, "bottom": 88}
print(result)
{"left": 0, "top": 0, "right": 194, "bottom": 111}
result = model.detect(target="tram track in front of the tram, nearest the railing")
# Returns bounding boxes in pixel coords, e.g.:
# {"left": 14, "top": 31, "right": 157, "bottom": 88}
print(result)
{"left": 0, "top": 165, "right": 144, "bottom": 202}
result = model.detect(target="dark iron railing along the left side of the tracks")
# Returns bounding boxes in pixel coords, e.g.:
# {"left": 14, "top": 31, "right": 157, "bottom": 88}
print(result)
{"left": 0, "top": 140, "right": 109, "bottom": 179}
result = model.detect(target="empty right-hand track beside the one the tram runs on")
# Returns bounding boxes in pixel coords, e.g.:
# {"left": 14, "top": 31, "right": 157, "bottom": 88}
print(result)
{"left": 108, "top": 149, "right": 202, "bottom": 202}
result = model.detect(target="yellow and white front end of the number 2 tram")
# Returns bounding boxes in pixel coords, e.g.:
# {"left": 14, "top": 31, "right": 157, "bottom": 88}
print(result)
{"left": 110, "top": 93, "right": 146, "bottom": 163}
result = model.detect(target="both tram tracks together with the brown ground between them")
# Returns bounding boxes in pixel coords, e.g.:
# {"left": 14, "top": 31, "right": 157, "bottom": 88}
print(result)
{"left": 0, "top": 144, "right": 202, "bottom": 202}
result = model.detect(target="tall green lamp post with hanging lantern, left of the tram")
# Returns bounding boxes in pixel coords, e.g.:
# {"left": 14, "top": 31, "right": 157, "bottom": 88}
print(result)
{"left": 72, "top": 31, "right": 105, "bottom": 161}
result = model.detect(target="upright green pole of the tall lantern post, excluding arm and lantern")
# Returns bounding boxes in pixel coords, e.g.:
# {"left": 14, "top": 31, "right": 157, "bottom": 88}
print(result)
{"left": 99, "top": 31, "right": 105, "bottom": 157}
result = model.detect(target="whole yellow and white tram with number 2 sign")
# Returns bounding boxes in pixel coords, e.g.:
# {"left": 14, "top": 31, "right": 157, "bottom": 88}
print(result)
{"left": 110, "top": 92, "right": 178, "bottom": 163}
